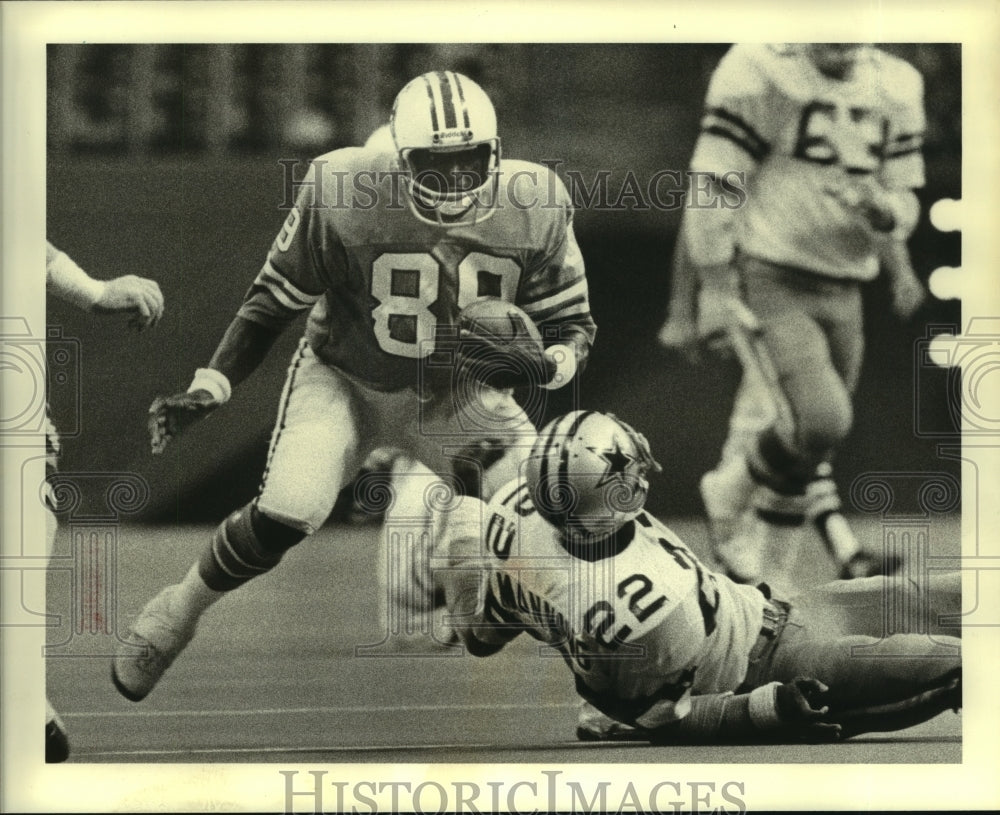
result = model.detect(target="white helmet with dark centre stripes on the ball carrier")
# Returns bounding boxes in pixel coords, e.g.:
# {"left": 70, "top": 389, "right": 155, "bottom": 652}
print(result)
{"left": 389, "top": 71, "right": 500, "bottom": 225}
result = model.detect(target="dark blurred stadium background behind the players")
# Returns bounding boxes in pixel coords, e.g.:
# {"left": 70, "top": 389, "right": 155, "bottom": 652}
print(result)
{"left": 47, "top": 45, "right": 961, "bottom": 522}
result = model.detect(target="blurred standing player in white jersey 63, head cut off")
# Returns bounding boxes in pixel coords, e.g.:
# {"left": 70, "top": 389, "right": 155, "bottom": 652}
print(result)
{"left": 661, "top": 44, "right": 924, "bottom": 582}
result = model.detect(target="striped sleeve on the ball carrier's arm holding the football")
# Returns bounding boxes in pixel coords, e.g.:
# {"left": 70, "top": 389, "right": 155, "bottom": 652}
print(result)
{"left": 517, "top": 179, "right": 597, "bottom": 362}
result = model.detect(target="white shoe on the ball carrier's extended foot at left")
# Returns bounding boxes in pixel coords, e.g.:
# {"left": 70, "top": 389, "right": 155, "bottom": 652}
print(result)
{"left": 111, "top": 585, "right": 198, "bottom": 702}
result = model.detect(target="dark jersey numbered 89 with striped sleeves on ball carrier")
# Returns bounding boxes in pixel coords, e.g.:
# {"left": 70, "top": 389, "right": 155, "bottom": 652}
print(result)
{"left": 239, "top": 148, "right": 596, "bottom": 390}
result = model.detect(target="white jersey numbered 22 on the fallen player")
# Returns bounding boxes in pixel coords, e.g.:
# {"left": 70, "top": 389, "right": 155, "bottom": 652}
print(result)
{"left": 476, "top": 480, "right": 766, "bottom": 722}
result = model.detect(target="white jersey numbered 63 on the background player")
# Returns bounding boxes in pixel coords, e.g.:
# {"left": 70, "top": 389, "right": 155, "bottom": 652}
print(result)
{"left": 689, "top": 45, "right": 925, "bottom": 280}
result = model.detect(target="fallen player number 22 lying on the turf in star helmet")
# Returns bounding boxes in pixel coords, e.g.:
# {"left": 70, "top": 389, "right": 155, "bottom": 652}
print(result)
{"left": 447, "top": 411, "right": 962, "bottom": 742}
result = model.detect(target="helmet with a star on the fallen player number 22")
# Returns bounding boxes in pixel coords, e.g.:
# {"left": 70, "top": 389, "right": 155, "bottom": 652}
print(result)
{"left": 526, "top": 410, "right": 662, "bottom": 538}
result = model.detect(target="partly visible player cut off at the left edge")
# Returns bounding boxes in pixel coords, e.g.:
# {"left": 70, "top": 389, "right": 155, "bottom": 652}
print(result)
{"left": 45, "top": 242, "right": 163, "bottom": 763}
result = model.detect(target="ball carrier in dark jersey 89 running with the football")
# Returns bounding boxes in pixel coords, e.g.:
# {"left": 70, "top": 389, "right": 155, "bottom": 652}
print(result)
{"left": 112, "top": 71, "right": 596, "bottom": 701}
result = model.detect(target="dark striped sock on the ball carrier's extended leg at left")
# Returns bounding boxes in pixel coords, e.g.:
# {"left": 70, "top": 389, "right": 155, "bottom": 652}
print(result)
{"left": 198, "top": 502, "right": 306, "bottom": 591}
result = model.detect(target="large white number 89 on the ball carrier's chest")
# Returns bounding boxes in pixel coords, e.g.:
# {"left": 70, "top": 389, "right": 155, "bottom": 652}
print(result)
{"left": 371, "top": 252, "right": 521, "bottom": 359}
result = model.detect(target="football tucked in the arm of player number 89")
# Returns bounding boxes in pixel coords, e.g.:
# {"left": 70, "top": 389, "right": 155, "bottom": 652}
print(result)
{"left": 456, "top": 297, "right": 555, "bottom": 388}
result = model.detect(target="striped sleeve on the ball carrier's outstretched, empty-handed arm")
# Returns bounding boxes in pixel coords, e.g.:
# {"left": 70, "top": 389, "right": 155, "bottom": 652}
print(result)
{"left": 237, "top": 164, "right": 331, "bottom": 328}
